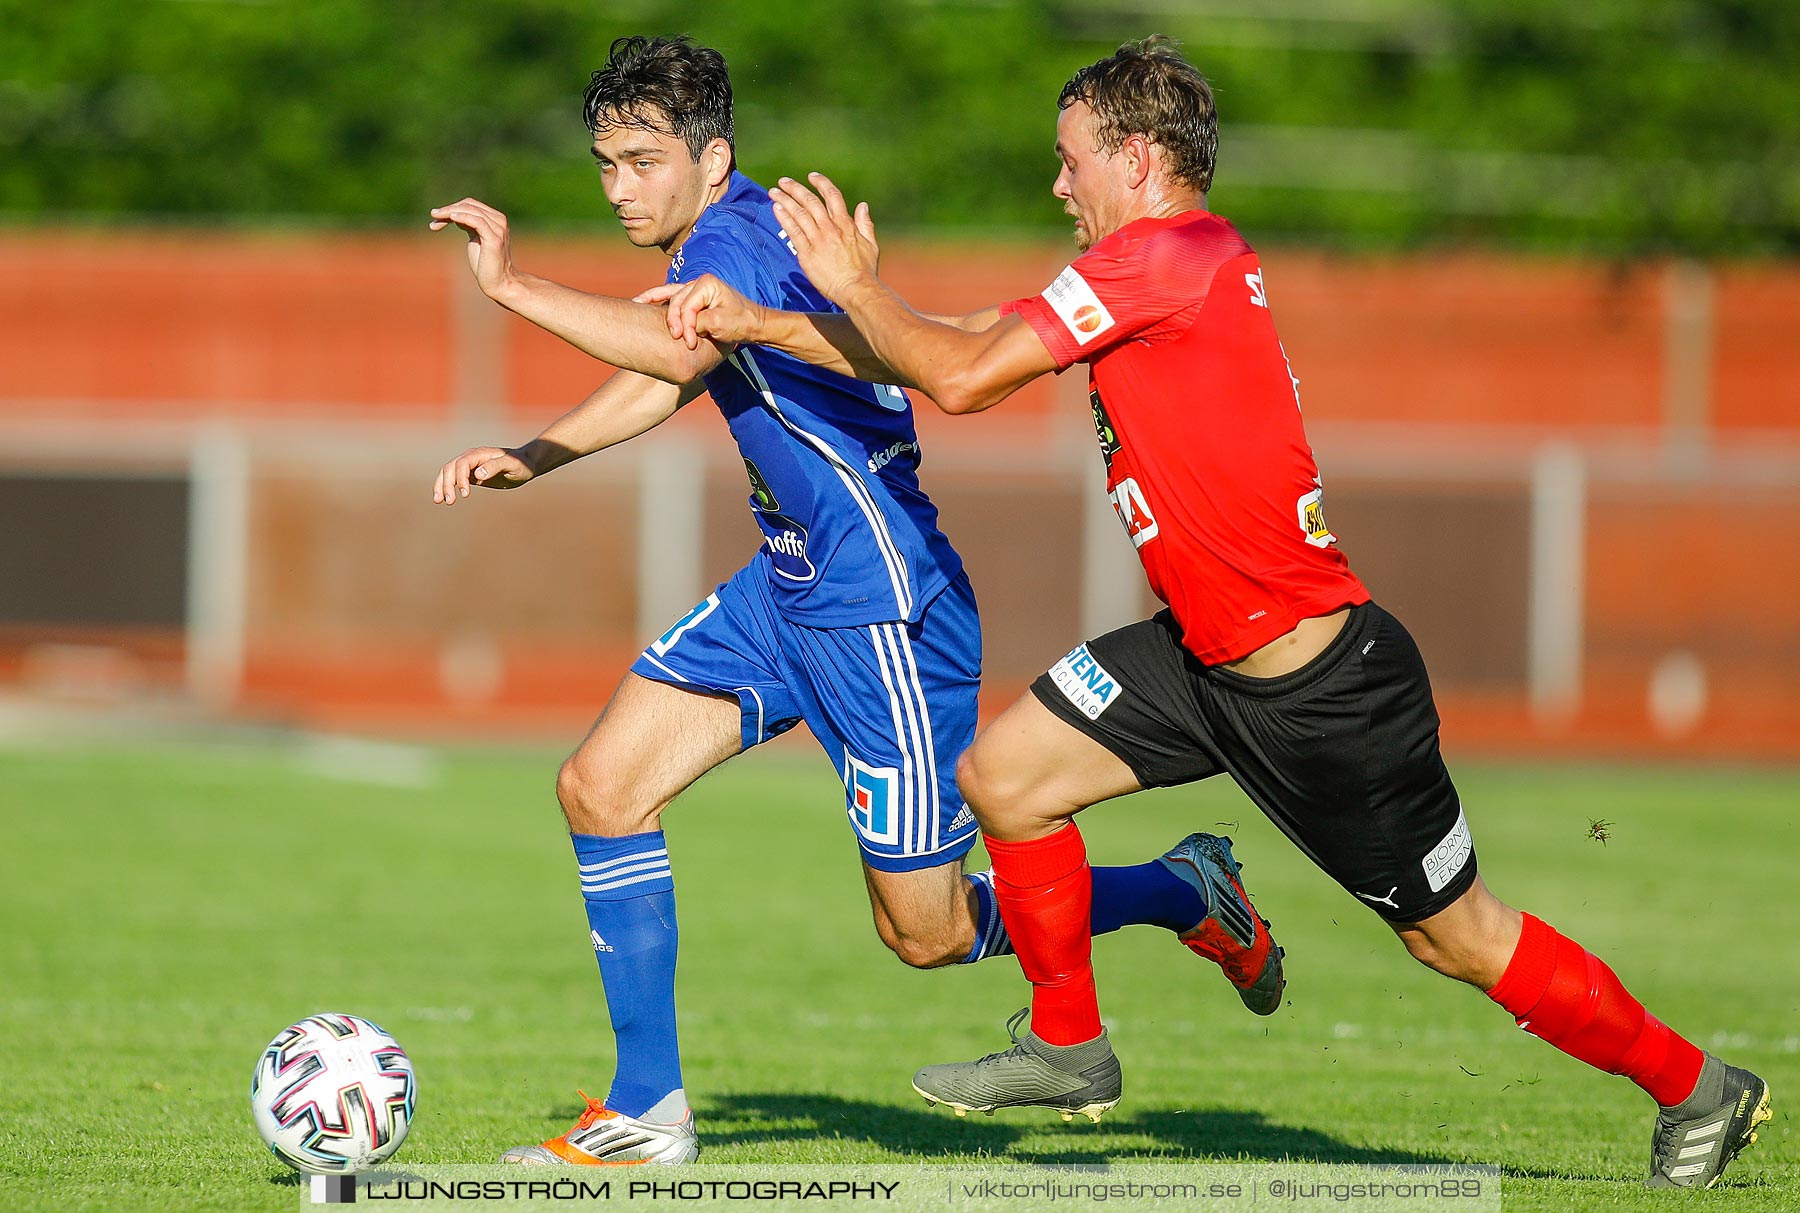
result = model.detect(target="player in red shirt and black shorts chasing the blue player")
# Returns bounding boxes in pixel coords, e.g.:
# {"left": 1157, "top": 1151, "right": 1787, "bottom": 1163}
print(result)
{"left": 657, "top": 38, "right": 1769, "bottom": 1186}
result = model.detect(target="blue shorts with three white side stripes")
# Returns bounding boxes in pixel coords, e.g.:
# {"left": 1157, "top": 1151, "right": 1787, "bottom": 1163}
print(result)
{"left": 632, "top": 563, "right": 981, "bottom": 871}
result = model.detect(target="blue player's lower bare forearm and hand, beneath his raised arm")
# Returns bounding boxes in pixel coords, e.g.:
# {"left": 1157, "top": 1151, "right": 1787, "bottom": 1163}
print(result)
{"left": 432, "top": 371, "right": 704, "bottom": 506}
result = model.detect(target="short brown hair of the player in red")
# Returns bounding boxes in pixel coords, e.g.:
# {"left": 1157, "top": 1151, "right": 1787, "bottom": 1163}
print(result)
{"left": 1057, "top": 34, "right": 1219, "bottom": 194}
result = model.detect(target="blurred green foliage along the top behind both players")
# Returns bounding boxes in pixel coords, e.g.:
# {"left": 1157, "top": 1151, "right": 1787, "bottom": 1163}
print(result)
{"left": 0, "top": 0, "right": 1800, "bottom": 256}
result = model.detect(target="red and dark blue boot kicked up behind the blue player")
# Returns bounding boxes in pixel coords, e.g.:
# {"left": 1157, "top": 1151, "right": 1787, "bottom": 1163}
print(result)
{"left": 1157, "top": 833, "right": 1287, "bottom": 1015}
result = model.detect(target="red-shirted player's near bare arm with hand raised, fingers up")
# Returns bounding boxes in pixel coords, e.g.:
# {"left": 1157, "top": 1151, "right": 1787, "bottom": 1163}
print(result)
{"left": 769, "top": 173, "right": 1057, "bottom": 412}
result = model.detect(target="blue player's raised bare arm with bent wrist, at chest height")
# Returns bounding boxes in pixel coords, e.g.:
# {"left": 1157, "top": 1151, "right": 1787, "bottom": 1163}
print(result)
{"left": 430, "top": 198, "right": 724, "bottom": 383}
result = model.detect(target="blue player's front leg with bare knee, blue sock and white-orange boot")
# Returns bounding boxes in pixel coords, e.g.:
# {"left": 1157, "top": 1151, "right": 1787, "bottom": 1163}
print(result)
{"left": 500, "top": 673, "right": 743, "bottom": 1166}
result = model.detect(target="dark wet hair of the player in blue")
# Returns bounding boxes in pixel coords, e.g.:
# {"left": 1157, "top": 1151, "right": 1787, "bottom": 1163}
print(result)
{"left": 581, "top": 34, "right": 736, "bottom": 160}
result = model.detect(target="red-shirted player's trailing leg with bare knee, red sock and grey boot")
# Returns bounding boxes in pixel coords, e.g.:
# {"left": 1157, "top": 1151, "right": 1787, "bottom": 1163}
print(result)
{"left": 1390, "top": 876, "right": 1773, "bottom": 1188}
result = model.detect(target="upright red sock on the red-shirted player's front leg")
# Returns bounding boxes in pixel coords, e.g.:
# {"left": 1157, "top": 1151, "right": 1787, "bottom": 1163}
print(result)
{"left": 981, "top": 821, "right": 1100, "bottom": 1044}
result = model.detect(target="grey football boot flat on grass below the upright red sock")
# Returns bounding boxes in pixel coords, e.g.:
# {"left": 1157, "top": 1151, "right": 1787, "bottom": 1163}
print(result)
{"left": 913, "top": 1008, "right": 1123, "bottom": 1123}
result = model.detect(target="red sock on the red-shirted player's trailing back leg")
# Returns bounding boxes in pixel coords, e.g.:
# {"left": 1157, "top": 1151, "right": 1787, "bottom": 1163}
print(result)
{"left": 1487, "top": 914, "right": 1705, "bottom": 1107}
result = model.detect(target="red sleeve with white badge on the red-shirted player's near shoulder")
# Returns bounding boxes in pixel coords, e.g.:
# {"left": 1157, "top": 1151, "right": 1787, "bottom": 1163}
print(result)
{"left": 1001, "top": 218, "right": 1249, "bottom": 371}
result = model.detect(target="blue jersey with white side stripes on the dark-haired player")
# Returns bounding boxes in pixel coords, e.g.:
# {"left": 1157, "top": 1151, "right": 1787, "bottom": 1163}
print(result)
{"left": 668, "top": 173, "right": 963, "bottom": 628}
